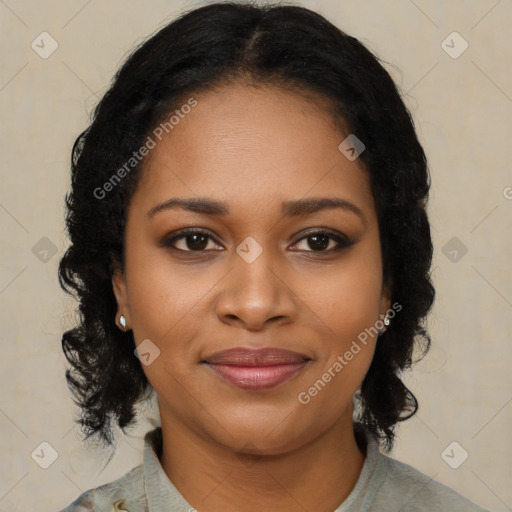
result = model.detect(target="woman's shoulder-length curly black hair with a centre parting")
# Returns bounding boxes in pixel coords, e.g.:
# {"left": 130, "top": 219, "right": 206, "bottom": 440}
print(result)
{"left": 59, "top": 2, "right": 435, "bottom": 449}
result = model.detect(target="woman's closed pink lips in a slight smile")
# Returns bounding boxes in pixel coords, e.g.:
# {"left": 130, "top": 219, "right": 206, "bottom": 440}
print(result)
{"left": 204, "top": 348, "right": 310, "bottom": 391}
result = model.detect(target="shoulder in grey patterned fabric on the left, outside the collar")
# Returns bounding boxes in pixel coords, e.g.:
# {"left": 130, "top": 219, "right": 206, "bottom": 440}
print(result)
{"left": 57, "top": 465, "right": 148, "bottom": 512}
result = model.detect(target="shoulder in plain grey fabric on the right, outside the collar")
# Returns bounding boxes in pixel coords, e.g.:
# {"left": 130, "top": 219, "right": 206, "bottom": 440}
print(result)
{"left": 375, "top": 454, "right": 486, "bottom": 512}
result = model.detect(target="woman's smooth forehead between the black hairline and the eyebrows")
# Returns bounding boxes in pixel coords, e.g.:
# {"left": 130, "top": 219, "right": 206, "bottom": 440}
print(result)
{"left": 133, "top": 85, "right": 373, "bottom": 218}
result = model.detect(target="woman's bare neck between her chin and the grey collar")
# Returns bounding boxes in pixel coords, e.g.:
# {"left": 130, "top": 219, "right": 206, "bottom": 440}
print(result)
{"left": 160, "top": 417, "right": 365, "bottom": 512}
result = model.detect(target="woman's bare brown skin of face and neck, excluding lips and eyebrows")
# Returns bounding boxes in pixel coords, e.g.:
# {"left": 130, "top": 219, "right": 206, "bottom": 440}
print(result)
{"left": 112, "top": 84, "right": 390, "bottom": 512}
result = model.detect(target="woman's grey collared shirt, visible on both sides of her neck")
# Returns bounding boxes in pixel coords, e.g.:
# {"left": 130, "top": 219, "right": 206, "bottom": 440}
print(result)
{"left": 61, "top": 427, "right": 488, "bottom": 512}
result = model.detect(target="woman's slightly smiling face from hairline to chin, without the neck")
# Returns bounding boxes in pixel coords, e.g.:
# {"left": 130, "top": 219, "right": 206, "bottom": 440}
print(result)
{"left": 113, "top": 85, "right": 390, "bottom": 454}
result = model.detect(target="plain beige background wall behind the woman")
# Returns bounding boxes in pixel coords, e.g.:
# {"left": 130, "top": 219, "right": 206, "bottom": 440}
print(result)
{"left": 0, "top": 0, "right": 512, "bottom": 512}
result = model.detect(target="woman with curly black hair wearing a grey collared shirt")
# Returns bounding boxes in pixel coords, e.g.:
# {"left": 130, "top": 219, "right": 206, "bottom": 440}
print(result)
{"left": 59, "top": 3, "right": 483, "bottom": 512}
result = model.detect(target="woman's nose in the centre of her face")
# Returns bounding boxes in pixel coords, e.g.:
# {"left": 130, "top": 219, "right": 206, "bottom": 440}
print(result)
{"left": 216, "top": 244, "right": 299, "bottom": 331}
